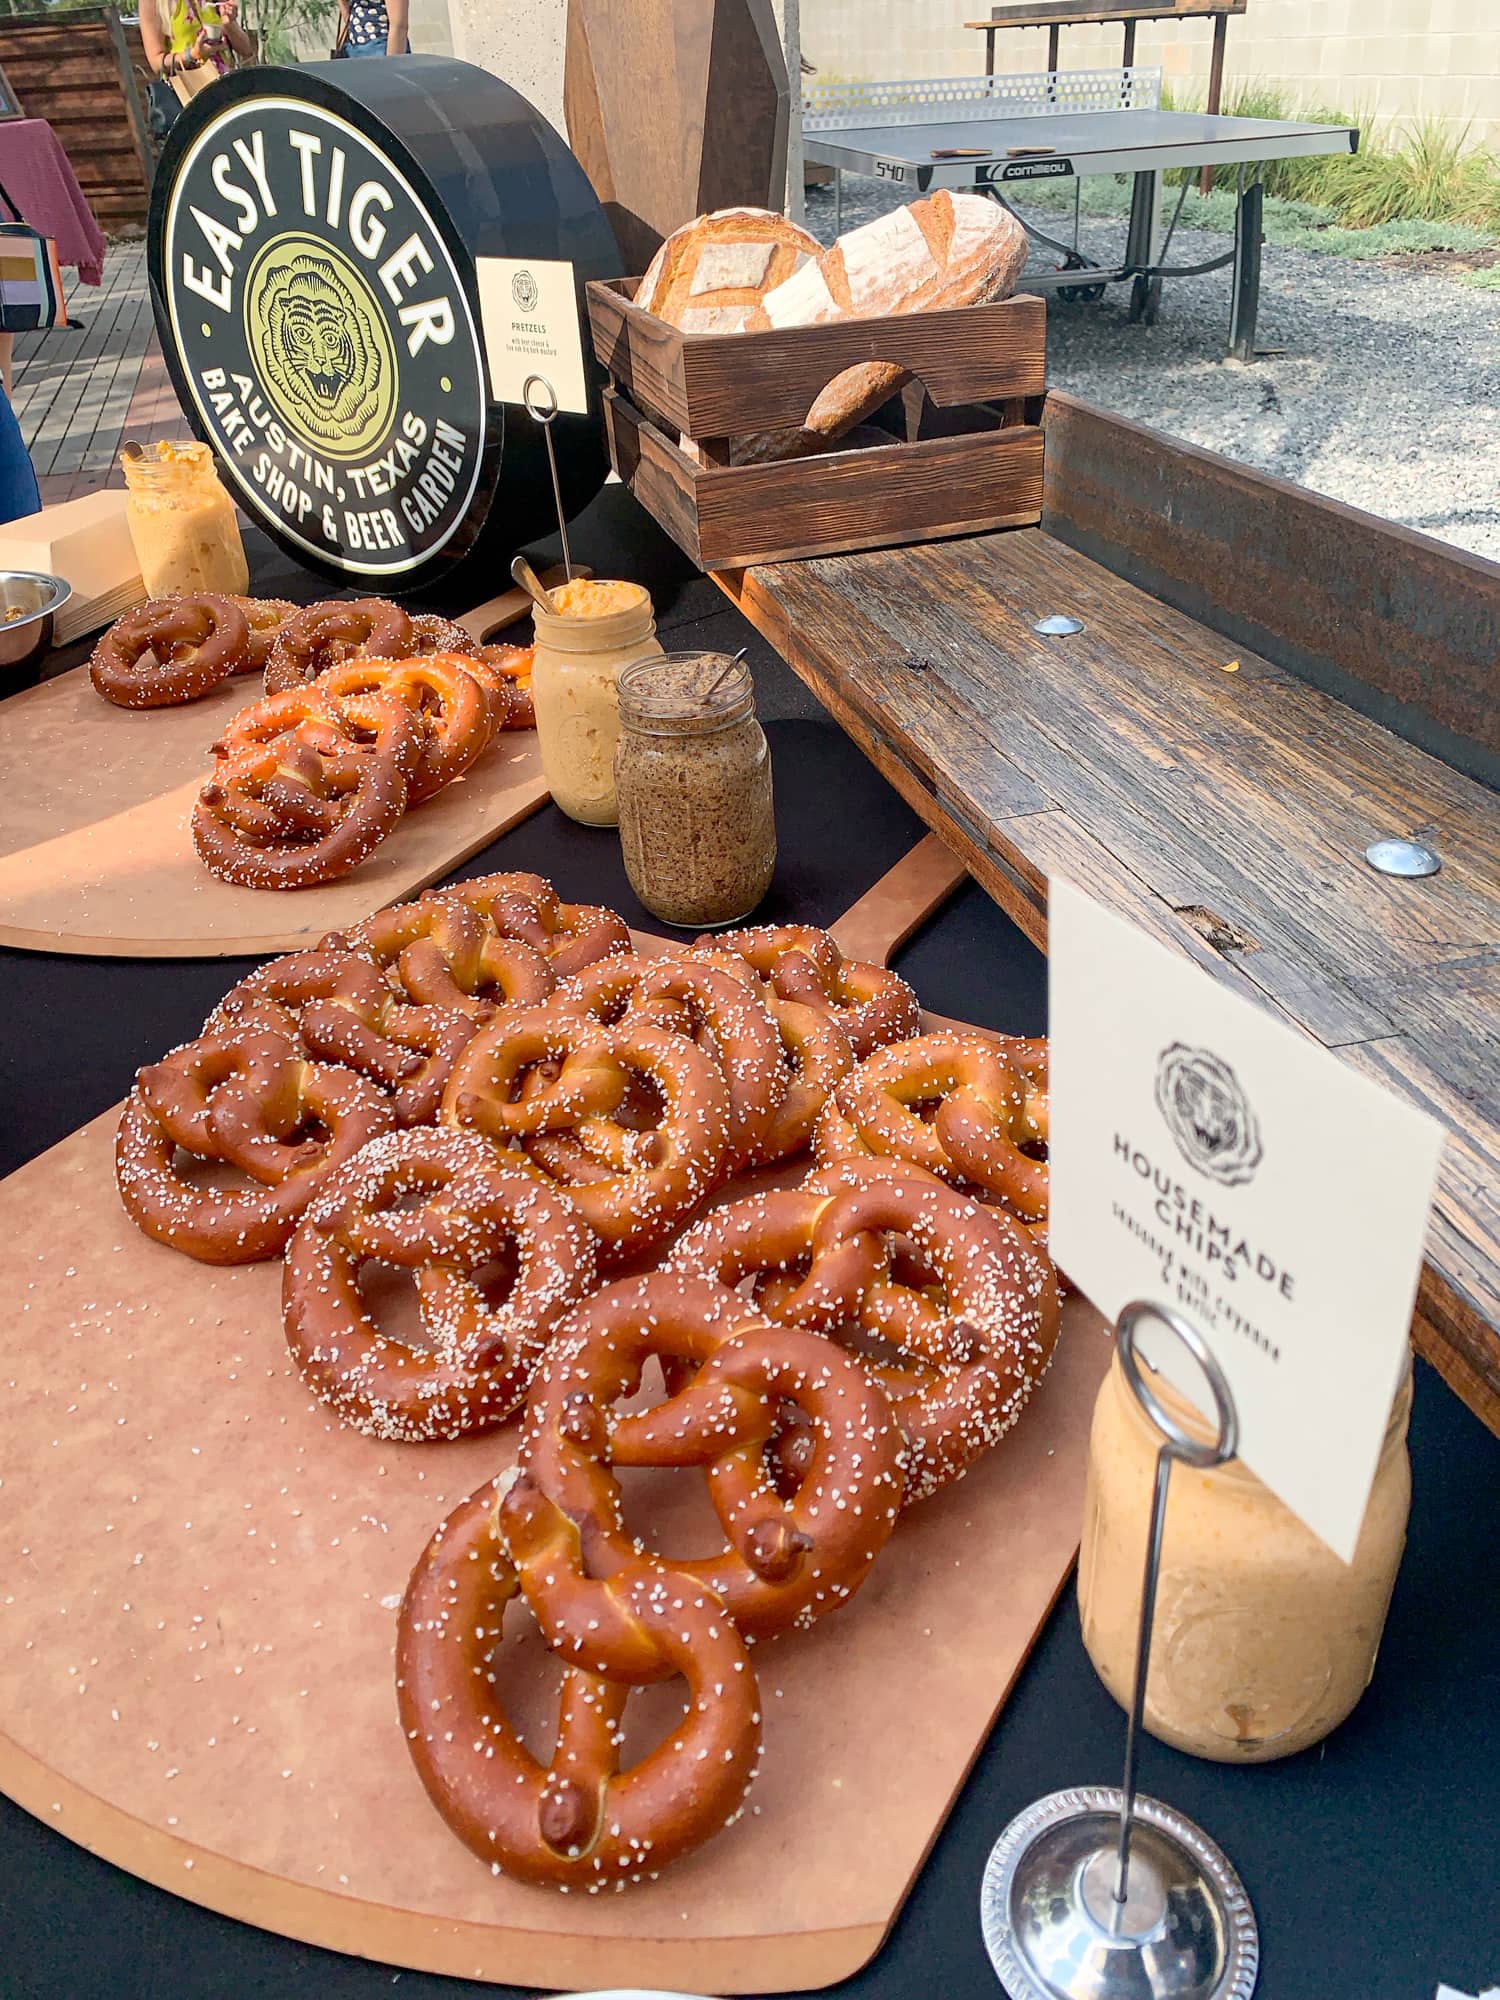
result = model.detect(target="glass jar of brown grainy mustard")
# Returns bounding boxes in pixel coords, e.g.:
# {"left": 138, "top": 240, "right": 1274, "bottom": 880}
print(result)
{"left": 614, "top": 652, "right": 776, "bottom": 930}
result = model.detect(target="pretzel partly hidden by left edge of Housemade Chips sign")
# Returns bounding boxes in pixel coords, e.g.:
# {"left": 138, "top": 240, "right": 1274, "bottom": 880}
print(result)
{"left": 814, "top": 1034, "right": 1048, "bottom": 1222}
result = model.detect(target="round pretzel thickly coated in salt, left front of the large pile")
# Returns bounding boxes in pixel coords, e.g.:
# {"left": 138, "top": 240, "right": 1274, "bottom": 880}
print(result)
{"left": 282, "top": 1132, "right": 594, "bottom": 1444}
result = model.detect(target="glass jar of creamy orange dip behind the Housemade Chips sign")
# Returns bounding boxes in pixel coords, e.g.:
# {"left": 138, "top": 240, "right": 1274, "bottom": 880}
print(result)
{"left": 1078, "top": 1354, "right": 1412, "bottom": 1764}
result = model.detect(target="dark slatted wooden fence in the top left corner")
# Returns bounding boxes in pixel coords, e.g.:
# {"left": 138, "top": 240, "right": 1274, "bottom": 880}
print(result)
{"left": 0, "top": 6, "right": 154, "bottom": 232}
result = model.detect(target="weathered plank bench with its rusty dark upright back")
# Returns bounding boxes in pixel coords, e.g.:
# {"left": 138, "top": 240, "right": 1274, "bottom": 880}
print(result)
{"left": 718, "top": 394, "right": 1500, "bottom": 1430}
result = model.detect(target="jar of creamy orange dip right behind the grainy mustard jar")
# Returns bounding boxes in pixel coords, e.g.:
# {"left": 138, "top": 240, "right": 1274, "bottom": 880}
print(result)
{"left": 532, "top": 578, "right": 662, "bottom": 826}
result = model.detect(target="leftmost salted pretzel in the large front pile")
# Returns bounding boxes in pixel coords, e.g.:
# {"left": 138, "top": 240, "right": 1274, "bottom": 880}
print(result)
{"left": 114, "top": 1032, "right": 396, "bottom": 1264}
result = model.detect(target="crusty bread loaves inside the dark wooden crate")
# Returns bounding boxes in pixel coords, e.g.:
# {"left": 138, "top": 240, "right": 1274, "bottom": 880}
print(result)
{"left": 636, "top": 188, "right": 1026, "bottom": 464}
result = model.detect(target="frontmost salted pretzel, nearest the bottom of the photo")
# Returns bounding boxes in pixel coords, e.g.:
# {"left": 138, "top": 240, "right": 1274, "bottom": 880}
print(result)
{"left": 396, "top": 1480, "right": 760, "bottom": 1892}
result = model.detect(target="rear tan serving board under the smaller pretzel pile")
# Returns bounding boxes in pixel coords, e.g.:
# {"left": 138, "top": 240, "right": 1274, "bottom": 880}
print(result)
{"left": 0, "top": 572, "right": 560, "bottom": 958}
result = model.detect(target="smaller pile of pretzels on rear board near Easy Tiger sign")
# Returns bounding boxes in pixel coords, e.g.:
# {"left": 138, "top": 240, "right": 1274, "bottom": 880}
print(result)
{"left": 90, "top": 596, "right": 536, "bottom": 888}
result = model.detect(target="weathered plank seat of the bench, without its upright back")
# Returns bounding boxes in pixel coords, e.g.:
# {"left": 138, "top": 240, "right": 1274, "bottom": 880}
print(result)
{"left": 720, "top": 500, "right": 1500, "bottom": 1430}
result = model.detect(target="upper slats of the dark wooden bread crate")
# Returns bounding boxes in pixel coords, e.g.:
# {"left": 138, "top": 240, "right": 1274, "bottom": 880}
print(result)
{"left": 588, "top": 280, "right": 1046, "bottom": 438}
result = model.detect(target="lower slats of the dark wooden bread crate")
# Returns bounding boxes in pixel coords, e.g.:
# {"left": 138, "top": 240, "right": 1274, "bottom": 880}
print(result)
{"left": 606, "top": 390, "right": 1042, "bottom": 570}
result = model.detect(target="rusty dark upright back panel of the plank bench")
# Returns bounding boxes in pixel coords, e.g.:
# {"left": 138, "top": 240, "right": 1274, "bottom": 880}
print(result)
{"left": 1042, "top": 394, "right": 1500, "bottom": 784}
